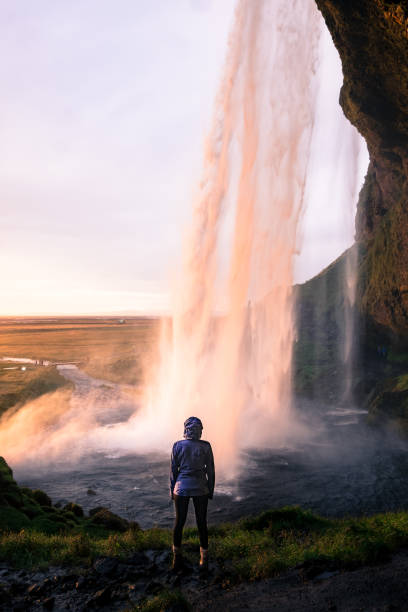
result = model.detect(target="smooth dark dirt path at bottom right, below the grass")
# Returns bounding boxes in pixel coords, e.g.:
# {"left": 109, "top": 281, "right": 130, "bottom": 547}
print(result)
{"left": 190, "top": 550, "right": 408, "bottom": 612}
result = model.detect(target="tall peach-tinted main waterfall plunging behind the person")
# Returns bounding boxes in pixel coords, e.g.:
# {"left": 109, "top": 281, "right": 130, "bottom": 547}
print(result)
{"left": 143, "top": 0, "right": 320, "bottom": 474}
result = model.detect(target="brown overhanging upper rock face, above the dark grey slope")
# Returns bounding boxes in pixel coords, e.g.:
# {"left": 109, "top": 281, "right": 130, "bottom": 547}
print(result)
{"left": 316, "top": 0, "right": 408, "bottom": 344}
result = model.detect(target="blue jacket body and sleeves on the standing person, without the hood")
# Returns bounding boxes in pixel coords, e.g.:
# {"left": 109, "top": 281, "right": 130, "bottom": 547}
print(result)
{"left": 170, "top": 439, "right": 215, "bottom": 499}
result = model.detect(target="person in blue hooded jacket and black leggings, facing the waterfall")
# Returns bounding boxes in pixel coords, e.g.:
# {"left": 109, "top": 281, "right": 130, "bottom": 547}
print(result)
{"left": 170, "top": 417, "right": 215, "bottom": 569}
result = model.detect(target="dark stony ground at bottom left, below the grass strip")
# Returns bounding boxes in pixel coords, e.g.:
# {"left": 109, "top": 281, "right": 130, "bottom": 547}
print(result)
{"left": 0, "top": 550, "right": 175, "bottom": 612}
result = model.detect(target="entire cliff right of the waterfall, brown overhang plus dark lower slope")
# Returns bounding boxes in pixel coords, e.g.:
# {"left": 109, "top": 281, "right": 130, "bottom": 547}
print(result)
{"left": 294, "top": 0, "right": 408, "bottom": 416}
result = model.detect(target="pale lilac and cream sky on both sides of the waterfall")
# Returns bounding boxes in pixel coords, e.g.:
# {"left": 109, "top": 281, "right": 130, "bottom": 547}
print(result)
{"left": 0, "top": 0, "right": 367, "bottom": 315}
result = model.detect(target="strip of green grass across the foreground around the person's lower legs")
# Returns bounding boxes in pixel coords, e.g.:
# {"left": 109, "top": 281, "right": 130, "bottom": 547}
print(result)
{"left": 0, "top": 508, "right": 408, "bottom": 580}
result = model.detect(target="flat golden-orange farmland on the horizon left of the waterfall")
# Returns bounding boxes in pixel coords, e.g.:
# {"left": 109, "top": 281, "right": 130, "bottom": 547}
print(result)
{"left": 0, "top": 317, "right": 160, "bottom": 413}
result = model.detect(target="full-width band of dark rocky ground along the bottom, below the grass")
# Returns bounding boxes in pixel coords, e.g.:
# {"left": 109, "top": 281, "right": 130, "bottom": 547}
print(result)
{"left": 0, "top": 550, "right": 408, "bottom": 612}
